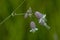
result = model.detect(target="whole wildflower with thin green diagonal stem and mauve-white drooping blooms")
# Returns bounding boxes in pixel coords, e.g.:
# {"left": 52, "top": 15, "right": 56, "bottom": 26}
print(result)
{"left": 0, "top": 0, "right": 50, "bottom": 32}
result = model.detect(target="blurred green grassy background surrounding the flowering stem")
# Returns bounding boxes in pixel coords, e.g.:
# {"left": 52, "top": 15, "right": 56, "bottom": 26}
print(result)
{"left": 0, "top": 0, "right": 60, "bottom": 40}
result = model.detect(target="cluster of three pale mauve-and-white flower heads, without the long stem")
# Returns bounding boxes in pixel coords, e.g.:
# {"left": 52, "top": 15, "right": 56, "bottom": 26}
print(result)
{"left": 24, "top": 7, "right": 50, "bottom": 32}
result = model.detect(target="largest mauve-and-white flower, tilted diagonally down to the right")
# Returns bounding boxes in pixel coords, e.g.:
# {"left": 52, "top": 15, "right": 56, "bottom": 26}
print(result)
{"left": 35, "top": 11, "right": 50, "bottom": 29}
